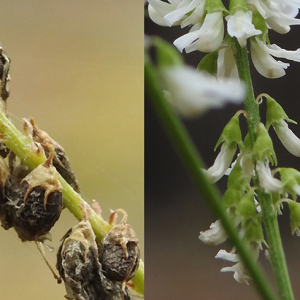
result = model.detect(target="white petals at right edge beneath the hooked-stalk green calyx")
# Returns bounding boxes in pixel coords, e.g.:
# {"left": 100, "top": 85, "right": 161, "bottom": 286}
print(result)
{"left": 273, "top": 121, "right": 300, "bottom": 157}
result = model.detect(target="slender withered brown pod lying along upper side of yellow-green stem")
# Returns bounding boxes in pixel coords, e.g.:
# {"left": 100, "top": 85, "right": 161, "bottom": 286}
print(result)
{"left": 24, "top": 119, "right": 80, "bottom": 193}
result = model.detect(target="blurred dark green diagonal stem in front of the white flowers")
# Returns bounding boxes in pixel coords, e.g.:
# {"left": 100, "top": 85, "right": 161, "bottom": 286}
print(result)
{"left": 145, "top": 55, "right": 276, "bottom": 300}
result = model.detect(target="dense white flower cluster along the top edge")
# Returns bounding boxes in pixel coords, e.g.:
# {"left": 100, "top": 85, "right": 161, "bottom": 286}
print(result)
{"left": 148, "top": 0, "right": 300, "bottom": 78}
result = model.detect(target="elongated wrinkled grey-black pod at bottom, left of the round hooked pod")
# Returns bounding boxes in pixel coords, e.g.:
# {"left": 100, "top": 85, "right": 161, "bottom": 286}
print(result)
{"left": 56, "top": 212, "right": 132, "bottom": 300}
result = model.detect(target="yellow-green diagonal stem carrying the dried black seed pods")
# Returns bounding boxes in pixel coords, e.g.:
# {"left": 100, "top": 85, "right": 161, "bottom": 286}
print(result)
{"left": 0, "top": 108, "right": 144, "bottom": 295}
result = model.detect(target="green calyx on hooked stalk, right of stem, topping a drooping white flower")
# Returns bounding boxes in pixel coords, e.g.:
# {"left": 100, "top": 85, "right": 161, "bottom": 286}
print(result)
{"left": 266, "top": 95, "right": 297, "bottom": 130}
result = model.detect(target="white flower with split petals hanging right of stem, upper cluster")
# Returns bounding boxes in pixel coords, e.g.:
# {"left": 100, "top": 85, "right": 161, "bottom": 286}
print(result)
{"left": 251, "top": 37, "right": 300, "bottom": 78}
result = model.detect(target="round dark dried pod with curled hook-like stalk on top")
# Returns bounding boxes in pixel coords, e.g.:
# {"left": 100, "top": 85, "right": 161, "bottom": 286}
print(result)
{"left": 99, "top": 209, "right": 140, "bottom": 283}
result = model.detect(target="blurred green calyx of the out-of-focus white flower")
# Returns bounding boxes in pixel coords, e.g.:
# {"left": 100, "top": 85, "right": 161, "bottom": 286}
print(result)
{"left": 153, "top": 37, "right": 184, "bottom": 69}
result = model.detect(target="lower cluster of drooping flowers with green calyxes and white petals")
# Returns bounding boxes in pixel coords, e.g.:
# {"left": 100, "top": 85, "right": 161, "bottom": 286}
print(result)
{"left": 199, "top": 95, "right": 300, "bottom": 283}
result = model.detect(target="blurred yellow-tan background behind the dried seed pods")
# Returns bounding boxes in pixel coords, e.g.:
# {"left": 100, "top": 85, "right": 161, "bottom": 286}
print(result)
{"left": 0, "top": 0, "right": 144, "bottom": 300}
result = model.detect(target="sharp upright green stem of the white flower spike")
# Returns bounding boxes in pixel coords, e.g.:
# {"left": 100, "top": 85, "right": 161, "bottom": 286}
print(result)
{"left": 236, "top": 41, "right": 294, "bottom": 300}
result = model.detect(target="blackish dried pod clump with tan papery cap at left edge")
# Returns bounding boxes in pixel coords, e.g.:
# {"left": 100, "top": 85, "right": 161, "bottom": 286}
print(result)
{"left": 0, "top": 155, "right": 63, "bottom": 241}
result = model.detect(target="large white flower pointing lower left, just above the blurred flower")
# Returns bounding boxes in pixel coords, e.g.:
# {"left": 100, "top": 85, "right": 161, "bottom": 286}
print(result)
{"left": 174, "top": 12, "right": 224, "bottom": 53}
